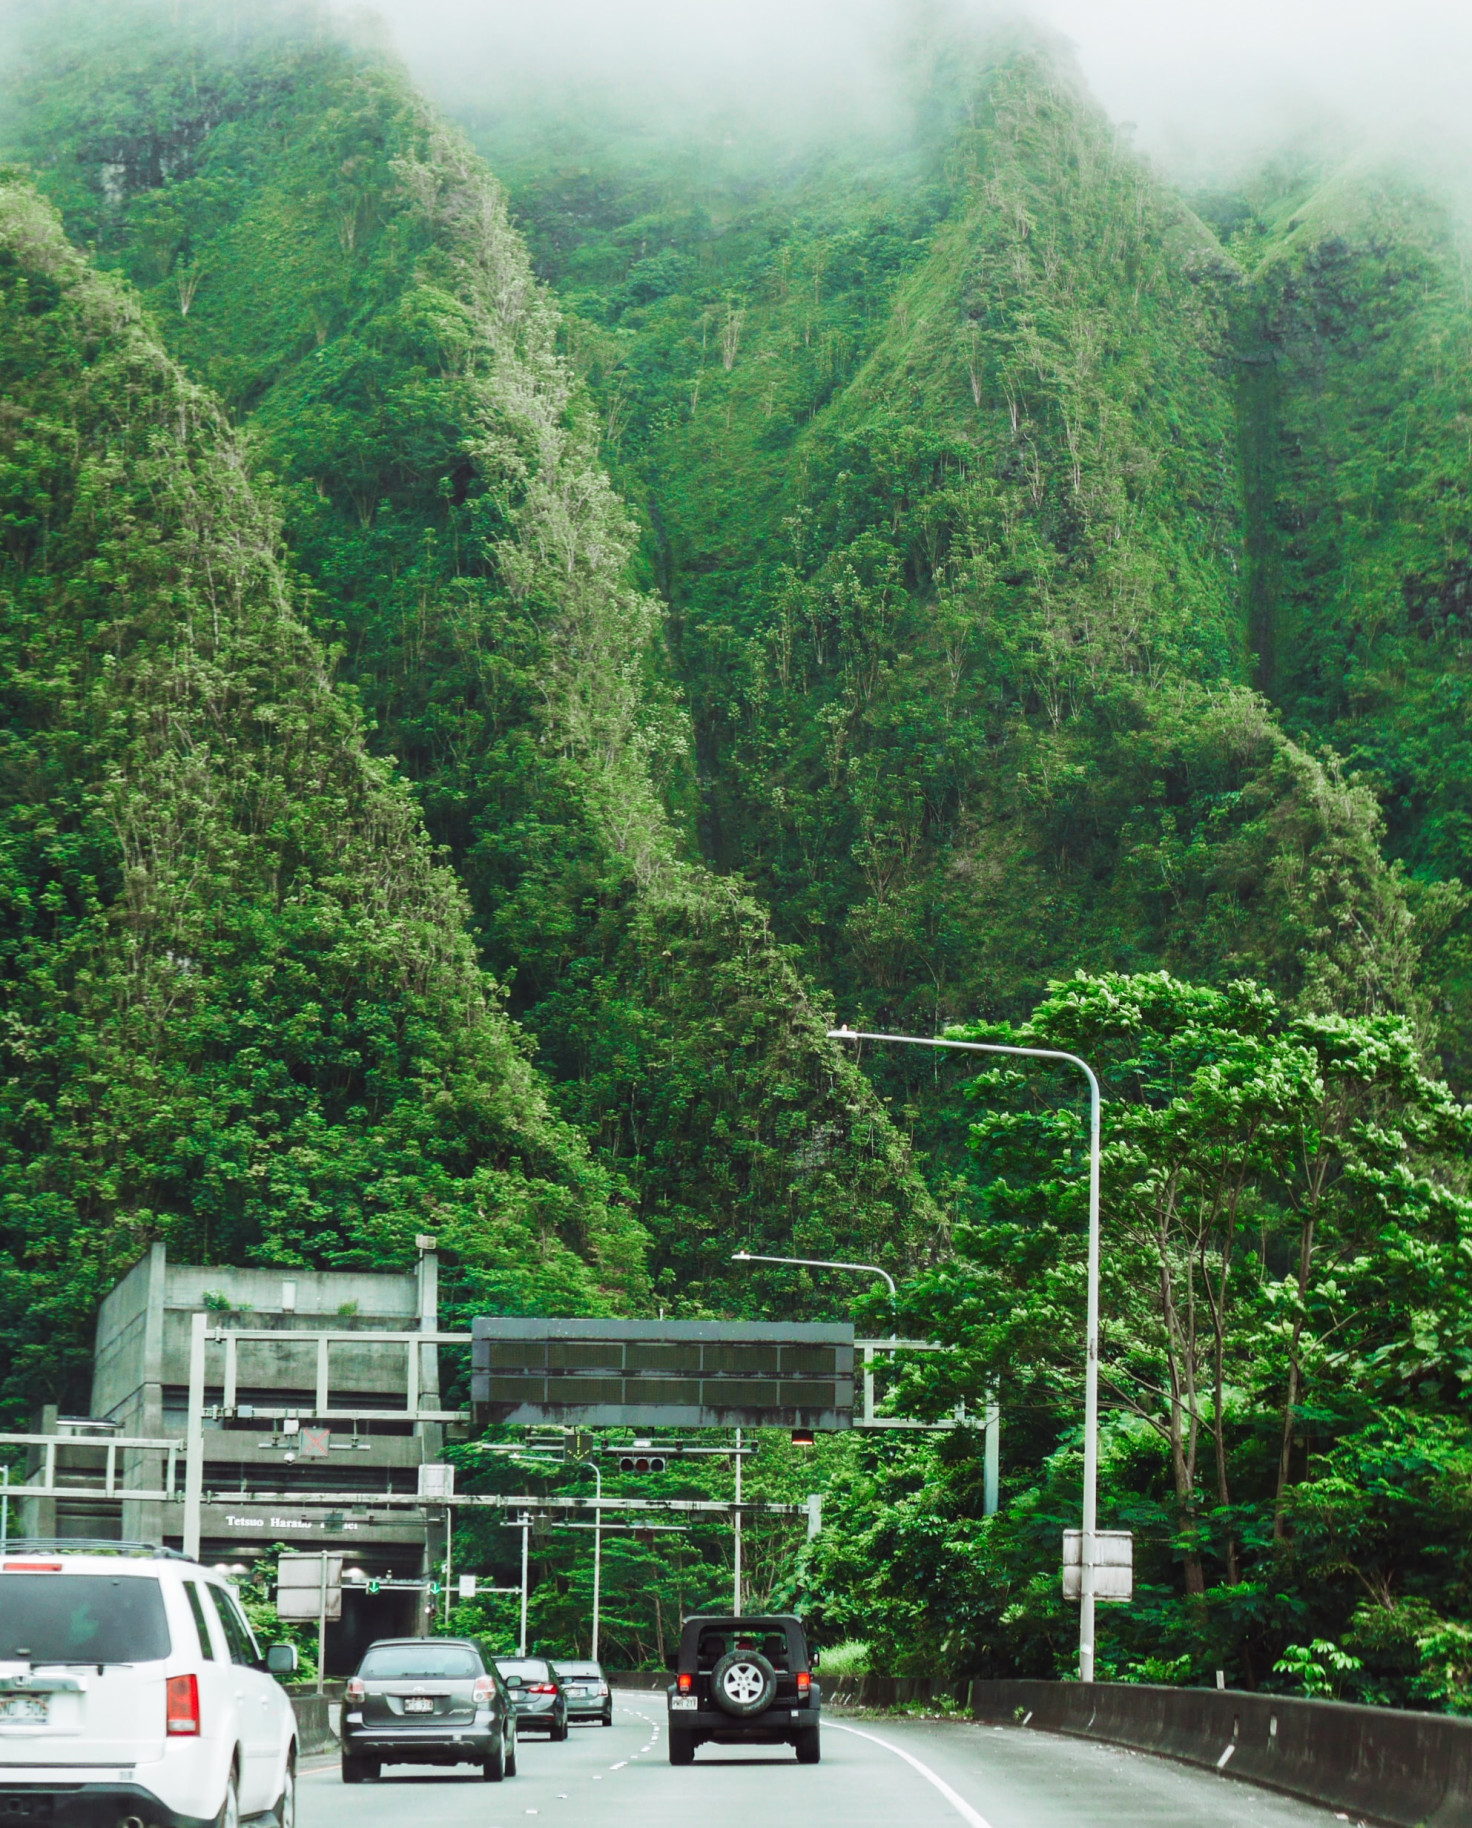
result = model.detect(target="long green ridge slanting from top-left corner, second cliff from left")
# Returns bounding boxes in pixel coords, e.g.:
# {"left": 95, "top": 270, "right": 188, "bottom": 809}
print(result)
{"left": 0, "top": 5, "right": 934, "bottom": 1305}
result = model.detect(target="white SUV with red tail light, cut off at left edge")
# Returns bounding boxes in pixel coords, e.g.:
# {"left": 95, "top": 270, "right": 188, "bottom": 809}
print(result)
{"left": 0, "top": 1543, "right": 296, "bottom": 1828}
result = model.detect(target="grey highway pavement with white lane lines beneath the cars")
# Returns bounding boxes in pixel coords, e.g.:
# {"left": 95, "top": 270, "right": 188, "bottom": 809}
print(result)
{"left": 298, "top": 1691, "right": 1344, "bottom": 1828}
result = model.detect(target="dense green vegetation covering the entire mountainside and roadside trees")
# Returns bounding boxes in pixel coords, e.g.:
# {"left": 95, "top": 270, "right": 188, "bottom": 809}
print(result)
{"left": 0, "top": 0, "right": 1472, "bottom": 1709}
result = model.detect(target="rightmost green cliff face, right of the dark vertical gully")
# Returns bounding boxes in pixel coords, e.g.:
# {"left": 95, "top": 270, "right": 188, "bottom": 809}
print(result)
{"left": 1216, "top": 161, "right": 1472, "bottom": 1073}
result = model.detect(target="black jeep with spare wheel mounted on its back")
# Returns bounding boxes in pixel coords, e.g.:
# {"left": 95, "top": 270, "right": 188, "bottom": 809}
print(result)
{"left": 669, "top": 1612, "right": 821, "bottom": 1764}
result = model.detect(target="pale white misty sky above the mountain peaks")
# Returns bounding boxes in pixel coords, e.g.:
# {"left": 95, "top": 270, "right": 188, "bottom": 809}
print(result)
{"left": 362, "top": 0, "right": 1472, "bottom": 175}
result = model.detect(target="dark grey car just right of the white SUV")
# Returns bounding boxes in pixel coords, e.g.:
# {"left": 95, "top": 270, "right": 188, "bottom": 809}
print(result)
{"left": 342, "top": 1638, "right": 516, "bottom": 1784}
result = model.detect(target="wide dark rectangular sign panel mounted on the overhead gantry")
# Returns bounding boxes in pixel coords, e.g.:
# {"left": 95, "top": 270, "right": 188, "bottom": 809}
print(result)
{"left": 470, "top": 1314, "right": 854, "bottom": 1429}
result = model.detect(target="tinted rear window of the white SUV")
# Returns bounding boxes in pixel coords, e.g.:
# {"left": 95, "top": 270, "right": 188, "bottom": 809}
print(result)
{"left": 0, "top": 1574, "right": 170, "bottom": 1663}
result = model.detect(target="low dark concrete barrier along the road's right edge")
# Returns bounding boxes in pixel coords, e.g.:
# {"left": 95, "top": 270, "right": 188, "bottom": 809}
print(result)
{"left": 971, "top": 1682, "right": 1472, "bottom": 1828}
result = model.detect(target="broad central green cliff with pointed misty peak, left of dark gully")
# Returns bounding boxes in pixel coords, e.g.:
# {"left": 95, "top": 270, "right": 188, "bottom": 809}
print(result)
{"left": 481, "top": 40, "right": 1415, "bottom": 1097}
